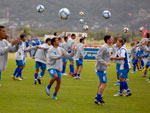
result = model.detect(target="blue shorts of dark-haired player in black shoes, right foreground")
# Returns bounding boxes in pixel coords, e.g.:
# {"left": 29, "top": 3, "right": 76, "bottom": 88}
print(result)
{"left": 96, "top": 71, "right": 107, "bottom": 84}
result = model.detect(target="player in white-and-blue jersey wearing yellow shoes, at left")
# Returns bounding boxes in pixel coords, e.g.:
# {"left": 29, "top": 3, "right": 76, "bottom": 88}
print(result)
{"left": 11, "top": 34, "right": 26, "bottom": 80}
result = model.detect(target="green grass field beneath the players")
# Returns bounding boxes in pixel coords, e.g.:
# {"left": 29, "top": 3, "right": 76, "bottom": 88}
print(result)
{"left": 0, "top": 59, "right": 150, "bottom": 113}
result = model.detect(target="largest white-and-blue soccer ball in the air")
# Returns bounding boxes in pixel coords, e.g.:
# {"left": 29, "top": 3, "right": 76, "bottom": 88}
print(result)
{"left": 58, "top": 8, "right": 70, "bottom": 20}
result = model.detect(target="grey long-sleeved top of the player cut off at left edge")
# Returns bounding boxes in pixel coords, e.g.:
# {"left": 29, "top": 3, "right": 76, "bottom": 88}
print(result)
{"left": 0, "top": 40, "right": 18, "bottom": 72}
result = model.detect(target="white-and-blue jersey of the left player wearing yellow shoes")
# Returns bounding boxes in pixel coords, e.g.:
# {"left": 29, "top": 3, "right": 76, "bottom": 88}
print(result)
{"left": 15, "top": 41, "right": 26, "bottom": 60}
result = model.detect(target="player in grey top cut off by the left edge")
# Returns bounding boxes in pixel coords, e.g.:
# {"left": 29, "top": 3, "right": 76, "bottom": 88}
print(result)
{"left": 0, "top": 26, "right": 20, "bottom": 86}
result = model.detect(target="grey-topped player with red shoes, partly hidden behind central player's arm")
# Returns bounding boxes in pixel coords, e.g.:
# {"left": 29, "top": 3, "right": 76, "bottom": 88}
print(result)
{"left": 67, "top": 34, "right": 76, "bottom": 76}
